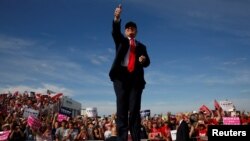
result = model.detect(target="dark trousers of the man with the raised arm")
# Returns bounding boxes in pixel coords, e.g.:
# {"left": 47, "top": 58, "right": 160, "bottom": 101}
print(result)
{"left": 113, "top": 68, "right": 143, "bottom": 141}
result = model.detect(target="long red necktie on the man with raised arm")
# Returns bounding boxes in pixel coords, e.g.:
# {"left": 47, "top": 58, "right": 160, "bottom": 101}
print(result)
{"left": 128, "top": 38, "right": 135, "bottom": 72}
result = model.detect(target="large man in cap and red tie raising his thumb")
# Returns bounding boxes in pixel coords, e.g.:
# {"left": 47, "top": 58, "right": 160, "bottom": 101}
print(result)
{"left": 109, "top": 5, "right": 150, "bottom": 141}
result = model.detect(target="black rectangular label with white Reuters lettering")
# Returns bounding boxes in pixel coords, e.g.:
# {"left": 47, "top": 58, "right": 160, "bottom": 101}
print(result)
{"left": 208, "top": 125, "right": 250, "bottom": 141}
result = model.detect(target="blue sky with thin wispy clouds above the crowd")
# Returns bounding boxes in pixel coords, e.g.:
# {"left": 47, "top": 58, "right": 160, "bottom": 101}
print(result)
{"left": 0, "top": 0, "right": 250, "bottom": 115}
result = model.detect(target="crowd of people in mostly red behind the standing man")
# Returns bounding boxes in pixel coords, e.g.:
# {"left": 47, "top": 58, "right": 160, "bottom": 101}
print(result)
{"left": 0, "top": 93, "right": 250, "bottom": 141}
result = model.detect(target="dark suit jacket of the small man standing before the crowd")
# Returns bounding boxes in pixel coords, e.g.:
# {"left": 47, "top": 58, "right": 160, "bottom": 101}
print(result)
{"left": 176, "top": 120, "right": 190, "bottom": 141}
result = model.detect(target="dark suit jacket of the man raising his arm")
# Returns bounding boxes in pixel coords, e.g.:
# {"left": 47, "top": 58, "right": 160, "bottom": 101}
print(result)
{"left": 109, "top": 20, "right": 150, "bottom": 88}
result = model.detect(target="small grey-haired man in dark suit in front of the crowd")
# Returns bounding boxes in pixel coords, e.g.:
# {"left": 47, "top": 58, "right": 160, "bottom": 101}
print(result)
{"left": 176, "top": 113, "right": 190, "bottom": 141}
